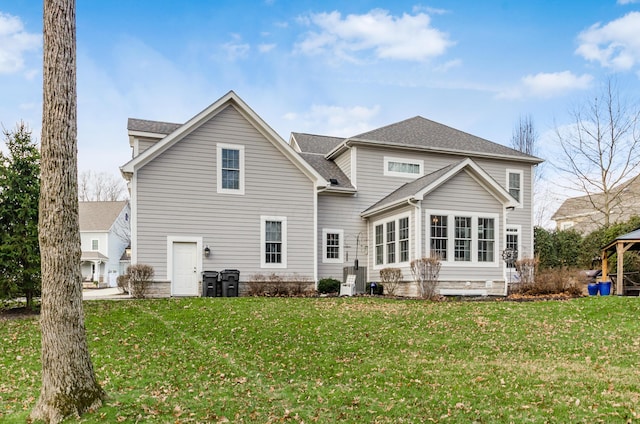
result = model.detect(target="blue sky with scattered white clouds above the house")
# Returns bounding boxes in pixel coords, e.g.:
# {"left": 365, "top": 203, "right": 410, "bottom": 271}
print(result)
{"left": 0, "top": 0, "right": 640, "bottom": 224}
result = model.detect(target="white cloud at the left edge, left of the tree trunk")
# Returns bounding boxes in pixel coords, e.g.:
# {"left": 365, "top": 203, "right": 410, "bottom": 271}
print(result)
{"left": 0, "top": 12, "right": 42, "bottom": 74}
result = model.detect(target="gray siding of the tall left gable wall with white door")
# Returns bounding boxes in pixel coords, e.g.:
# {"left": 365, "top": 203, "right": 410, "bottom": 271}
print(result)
{"left": 136, "top": 106, "right": 315, "bottom": 281}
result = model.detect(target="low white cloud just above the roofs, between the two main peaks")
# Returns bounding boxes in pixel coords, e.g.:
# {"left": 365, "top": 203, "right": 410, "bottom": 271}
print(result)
{"left": 284, "top": 105, "right": 380, "bottom": 137}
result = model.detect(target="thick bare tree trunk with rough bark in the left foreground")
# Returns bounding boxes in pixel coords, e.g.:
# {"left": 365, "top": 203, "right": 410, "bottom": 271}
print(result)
{"left": 31, "top": 0, "right": 105, "bottom": 423}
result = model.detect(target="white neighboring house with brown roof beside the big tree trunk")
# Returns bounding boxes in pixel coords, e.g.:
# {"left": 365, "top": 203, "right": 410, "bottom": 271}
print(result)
{"left": 79, "top": 201, "right": 131, "bottom": 287}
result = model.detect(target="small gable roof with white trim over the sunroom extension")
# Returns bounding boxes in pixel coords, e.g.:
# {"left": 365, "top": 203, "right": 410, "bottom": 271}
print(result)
{"left": 360, "top": 158, "right": 517, "bottom": 218}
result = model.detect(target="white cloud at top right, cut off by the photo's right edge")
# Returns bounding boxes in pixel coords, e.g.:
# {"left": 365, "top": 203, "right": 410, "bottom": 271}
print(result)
{"left": 576, "top": 12, "right": 640, "bottom": 71}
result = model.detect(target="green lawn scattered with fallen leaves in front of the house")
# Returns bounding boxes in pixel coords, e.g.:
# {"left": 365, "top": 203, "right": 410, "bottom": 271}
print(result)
{"left": 0, "top": 296, "right": 640, "bottom": 423}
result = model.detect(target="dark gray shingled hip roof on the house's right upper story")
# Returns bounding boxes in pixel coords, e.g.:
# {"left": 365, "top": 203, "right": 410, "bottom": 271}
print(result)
{"left": 327, "top": 116, "right": 542, "bottom": 163}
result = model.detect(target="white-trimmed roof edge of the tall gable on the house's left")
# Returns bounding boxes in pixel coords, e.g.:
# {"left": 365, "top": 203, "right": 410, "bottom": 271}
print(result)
{"left": 120, "top": 91, "right": 329, "bottom": 187}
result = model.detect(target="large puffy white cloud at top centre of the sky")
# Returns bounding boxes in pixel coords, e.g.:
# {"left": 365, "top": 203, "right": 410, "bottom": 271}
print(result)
{"left": 296, "top": 9, "right": 454, "bottom": 62}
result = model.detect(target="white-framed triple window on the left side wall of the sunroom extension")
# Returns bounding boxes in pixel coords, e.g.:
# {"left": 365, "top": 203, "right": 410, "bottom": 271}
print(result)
{"left": 374, "top": 216, "right": 410, "bottom": 266}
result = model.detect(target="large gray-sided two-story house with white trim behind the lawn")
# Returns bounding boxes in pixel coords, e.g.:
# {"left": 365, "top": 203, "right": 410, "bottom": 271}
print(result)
{"left": 121, "top": 92, "right": 541, "bottom": 296}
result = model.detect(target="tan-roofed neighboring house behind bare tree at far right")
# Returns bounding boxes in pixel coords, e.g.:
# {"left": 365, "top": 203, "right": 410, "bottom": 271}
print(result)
{"left": 551, "top": 176, "right": 640, "bottom": 234}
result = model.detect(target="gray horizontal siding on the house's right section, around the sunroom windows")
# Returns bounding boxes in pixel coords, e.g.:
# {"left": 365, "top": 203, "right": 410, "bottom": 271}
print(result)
{"left": 318, "top": 146, "right": 533, "bottom": 294}
